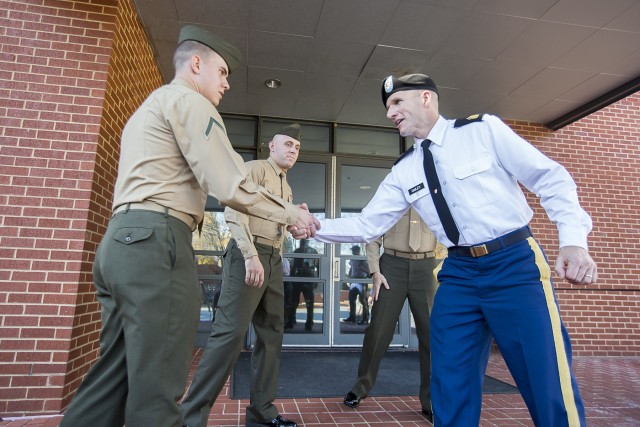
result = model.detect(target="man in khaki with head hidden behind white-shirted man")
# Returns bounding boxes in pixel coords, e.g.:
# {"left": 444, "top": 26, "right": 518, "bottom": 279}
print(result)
{"left": 344, "top": 208, "right": 437, "bottom": 421}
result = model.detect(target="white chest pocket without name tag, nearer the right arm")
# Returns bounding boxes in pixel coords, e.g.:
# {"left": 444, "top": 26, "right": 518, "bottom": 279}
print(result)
{"left": 453, "top": 154, "right": 500, "bottom": 207}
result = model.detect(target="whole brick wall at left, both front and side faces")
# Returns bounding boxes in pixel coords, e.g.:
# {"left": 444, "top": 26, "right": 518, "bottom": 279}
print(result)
{"left": 0, "top": 0, "right": 161, "bottom": 415}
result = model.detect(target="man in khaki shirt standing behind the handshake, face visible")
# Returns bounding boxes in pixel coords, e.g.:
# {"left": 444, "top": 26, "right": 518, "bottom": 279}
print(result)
{"left": 181, "top": 123, "right": 300, "bottom": 427}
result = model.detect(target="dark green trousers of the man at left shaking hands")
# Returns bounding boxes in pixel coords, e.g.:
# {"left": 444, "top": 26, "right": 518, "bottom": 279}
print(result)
{"left": 60, "top": 210, "right": 200, "bottom": 427}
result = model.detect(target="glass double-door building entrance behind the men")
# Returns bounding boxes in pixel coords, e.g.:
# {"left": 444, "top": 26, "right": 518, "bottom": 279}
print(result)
{"left": 194, "top": 155, "right": 417, "bottom": 347}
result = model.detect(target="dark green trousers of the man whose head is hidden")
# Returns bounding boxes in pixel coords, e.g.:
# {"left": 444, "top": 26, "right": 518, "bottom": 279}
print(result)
{"left": 351, "top": 254, "right": 436, "bottom": 409}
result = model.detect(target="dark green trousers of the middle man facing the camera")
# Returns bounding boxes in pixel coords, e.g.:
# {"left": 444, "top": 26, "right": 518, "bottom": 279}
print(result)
{"left": 182, "top": 239, "right": 284, "bottom": 427}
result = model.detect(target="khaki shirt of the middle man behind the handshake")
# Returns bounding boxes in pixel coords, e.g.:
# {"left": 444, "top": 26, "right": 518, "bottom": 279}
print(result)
{"left": 224, "top": 157, "right": 293, "bottom": 259}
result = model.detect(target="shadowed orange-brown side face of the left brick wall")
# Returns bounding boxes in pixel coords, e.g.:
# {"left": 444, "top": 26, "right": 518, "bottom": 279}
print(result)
{"left": 63, "top": 0, "right": 162, "bottom": 407}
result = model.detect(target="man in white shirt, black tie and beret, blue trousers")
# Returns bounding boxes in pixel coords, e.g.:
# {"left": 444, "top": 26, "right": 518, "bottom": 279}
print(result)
{"left": 290, "top": 74, "right": 598, "bottom": 427}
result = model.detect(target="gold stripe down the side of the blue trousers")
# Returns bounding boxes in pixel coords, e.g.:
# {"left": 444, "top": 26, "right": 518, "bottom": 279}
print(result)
{"left": 527, "top": 237, "right": 580, "bottom": 427}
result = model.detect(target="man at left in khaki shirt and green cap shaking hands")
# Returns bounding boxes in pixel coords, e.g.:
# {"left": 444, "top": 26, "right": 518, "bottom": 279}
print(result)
{"left": 61, "top": 25, "right": 317, "bottom": 427}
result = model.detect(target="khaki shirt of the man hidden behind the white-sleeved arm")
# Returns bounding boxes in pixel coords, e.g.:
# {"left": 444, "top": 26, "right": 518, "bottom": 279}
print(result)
{"left": 366, "top": 208, "right": 438, "bottom": 274}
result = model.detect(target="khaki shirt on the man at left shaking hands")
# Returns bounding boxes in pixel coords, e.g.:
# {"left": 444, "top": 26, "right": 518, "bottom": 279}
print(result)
{"left": 113, "top": 79, "right": 298, "bottom": 224}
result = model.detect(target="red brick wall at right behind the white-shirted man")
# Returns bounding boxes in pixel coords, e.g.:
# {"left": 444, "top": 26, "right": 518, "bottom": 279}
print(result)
{"left": 509, "top": 93, "right": 640, "bottom": 356}
